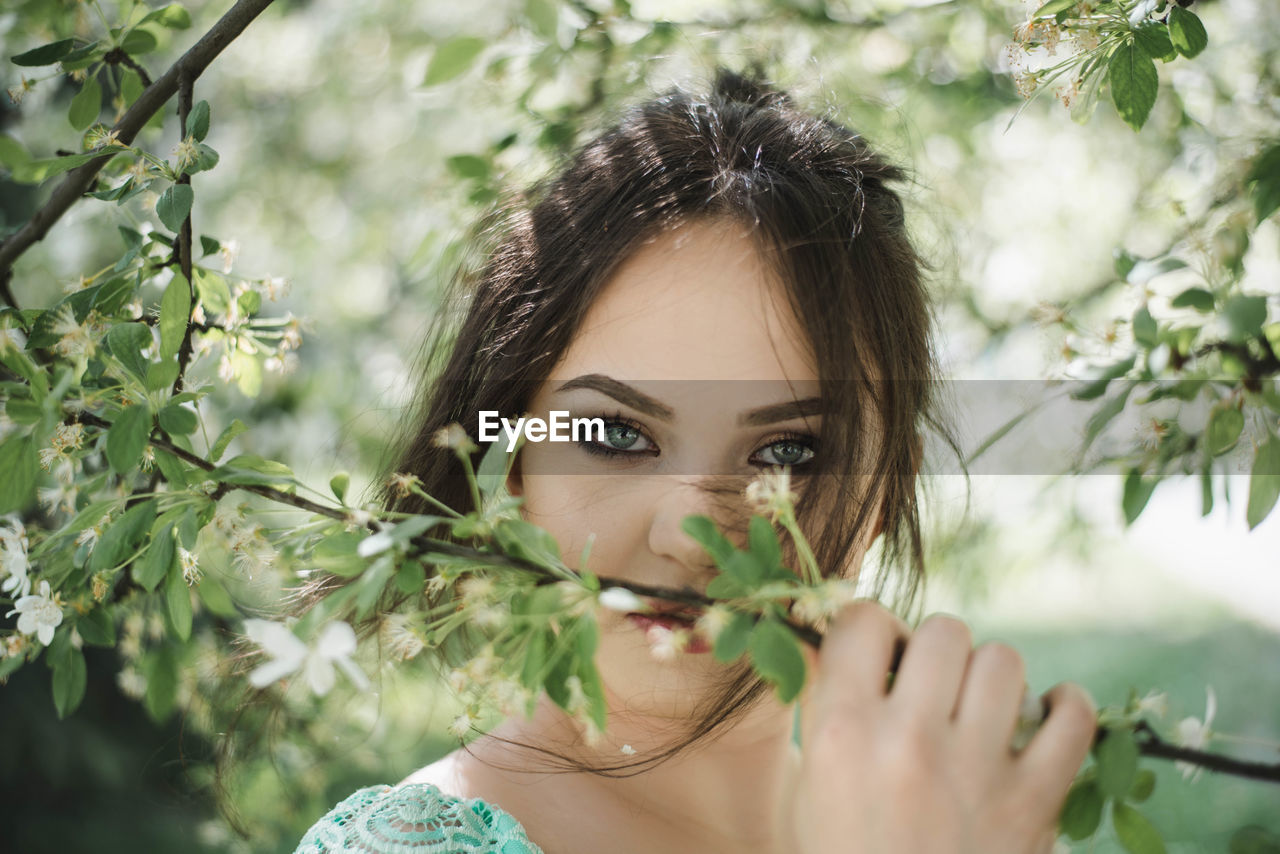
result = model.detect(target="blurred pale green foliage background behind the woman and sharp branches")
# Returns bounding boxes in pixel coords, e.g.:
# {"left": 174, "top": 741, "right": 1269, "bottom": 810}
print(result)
{"left": 0, "top": 0, "right": 1280, "bottom": 853}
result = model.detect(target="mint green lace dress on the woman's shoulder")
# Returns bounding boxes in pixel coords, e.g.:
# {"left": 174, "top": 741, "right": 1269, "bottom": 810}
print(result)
{"left": 293, "top": 782, "right": 543, "bottom": 854}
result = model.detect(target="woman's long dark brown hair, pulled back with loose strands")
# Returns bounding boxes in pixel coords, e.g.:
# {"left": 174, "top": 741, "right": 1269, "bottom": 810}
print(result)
{"left": 378, "top": 69, "right": 937, "bottom": 773}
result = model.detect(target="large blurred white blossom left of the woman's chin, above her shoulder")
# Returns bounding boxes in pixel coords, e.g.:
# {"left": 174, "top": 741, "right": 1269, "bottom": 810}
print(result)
{"left": 244, "top": 620, "right": 369, "bottom": 697}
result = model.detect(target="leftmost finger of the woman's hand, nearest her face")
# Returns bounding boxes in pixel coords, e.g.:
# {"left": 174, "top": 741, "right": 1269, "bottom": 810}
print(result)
{"left": 813, "top": 600, "right": 910, "bottom": 711}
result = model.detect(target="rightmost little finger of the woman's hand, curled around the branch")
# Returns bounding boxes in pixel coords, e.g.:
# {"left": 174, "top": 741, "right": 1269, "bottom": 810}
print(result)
{"left": 1018, "top": 682, "right": 1098, "bottom": 816}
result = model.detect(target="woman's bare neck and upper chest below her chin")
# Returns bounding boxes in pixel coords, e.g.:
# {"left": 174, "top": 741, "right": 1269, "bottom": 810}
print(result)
{"left": 466, "top": 695, "right": 795, "bottom": 854}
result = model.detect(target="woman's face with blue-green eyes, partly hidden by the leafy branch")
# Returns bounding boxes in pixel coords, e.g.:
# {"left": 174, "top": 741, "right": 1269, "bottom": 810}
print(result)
{"left": 509, "top": 220, "right": 860, "bottom": 727}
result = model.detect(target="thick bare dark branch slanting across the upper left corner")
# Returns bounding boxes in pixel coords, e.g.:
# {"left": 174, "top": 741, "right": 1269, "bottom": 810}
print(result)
{"left": 0, "top": 0, "right": 271, "bottom": 289}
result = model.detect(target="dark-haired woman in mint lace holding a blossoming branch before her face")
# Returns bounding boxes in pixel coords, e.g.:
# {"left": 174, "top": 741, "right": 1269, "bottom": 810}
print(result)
{"left": 298, "top": 70, "right": 1096, "bottom": 854}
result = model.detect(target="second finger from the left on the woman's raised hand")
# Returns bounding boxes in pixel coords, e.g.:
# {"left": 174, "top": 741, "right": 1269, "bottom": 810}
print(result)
{"left": 890, "top": 613, "right": 973, "bottom": 723}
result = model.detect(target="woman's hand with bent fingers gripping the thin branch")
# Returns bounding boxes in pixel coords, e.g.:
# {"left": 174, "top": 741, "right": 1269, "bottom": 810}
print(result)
{"left": 780, "top": 602, "right": 1097, "bottom": 854}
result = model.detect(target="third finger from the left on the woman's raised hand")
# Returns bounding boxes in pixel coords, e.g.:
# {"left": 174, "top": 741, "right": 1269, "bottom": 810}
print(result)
{"left": 955, "top": 643, "right": 1027, "bottom": 755}
